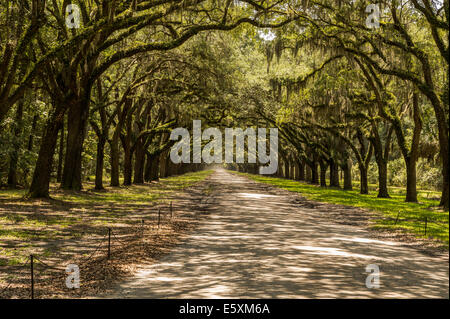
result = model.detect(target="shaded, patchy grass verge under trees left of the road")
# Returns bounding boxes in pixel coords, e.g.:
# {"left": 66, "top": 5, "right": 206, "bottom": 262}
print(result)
{"left": 0, "top": 171, "right": 212, "bottom": 268}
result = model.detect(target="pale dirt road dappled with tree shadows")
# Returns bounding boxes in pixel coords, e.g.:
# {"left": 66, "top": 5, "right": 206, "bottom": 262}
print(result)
{"left": 108, "top": 170, "right": 448, "bottom": 298}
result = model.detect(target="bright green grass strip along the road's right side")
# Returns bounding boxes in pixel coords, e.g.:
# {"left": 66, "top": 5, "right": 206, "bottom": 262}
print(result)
{"left": 233, "top": 172, "right": 449, "bottom": 249}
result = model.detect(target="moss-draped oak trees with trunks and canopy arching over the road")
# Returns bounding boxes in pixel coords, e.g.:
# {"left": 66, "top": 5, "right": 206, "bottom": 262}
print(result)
{"left": 0, "top": 0, "right": 449, "bottom": 210}
